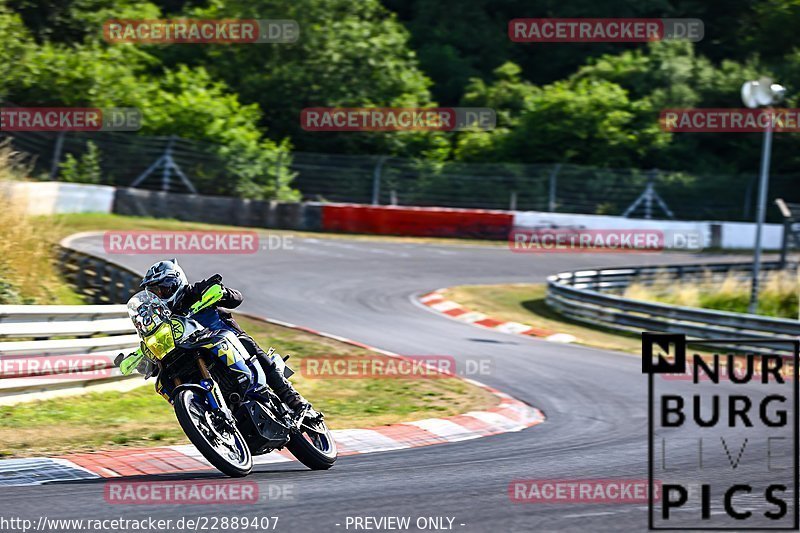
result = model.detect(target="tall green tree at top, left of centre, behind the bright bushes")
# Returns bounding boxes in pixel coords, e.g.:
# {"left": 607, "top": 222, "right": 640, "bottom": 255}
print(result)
{"left": 177, "top": 0, "right": 440, "bottom": 157}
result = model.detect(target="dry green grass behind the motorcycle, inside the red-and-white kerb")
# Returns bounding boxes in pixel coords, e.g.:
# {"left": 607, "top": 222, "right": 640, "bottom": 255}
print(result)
{"left": 0, "top": 317, "right": 497, "bottom": 457}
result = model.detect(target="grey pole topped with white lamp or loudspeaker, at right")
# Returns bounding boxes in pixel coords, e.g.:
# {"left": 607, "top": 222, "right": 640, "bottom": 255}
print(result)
{"left": 742, "top": 78, "right": 786, "bottom": 314}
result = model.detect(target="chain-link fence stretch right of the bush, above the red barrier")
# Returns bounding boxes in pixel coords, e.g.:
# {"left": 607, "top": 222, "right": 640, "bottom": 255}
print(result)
{"left": 284, "top": 152, "right": 800, "bottom": 220}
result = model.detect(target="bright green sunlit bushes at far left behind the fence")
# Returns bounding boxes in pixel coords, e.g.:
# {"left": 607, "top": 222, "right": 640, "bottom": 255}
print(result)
{"left": 0, "top": 0, "right": 298, "bottom": 200}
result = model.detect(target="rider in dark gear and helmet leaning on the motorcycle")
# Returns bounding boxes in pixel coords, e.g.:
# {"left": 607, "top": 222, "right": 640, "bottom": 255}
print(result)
{"left": 139, "top": 259, "right": 311, "bottom": 413}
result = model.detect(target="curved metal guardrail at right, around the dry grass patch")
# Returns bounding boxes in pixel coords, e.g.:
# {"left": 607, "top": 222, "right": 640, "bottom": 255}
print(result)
{"left": 547, "top": 262, "right": 800, "bottom": 353}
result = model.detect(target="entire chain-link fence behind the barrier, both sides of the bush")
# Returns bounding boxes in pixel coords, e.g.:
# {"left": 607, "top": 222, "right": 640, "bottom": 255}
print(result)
{"left": 3, "top": 132, "right": 800, "bottom": 221}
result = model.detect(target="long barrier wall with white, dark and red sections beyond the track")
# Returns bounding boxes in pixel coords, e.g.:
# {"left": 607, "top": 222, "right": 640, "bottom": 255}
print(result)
{"left": 6, "top": 182, "right": 783, "bottom": 250}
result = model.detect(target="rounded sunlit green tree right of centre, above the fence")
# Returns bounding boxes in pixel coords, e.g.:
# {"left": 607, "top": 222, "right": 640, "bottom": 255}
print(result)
{"left": 455, "top": 64, "right": 669, "bottom": 167}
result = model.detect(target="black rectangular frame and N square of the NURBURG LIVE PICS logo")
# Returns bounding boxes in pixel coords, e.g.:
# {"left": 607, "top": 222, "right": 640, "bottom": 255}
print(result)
{"left": 642, "top": 332, "right": 800, "bottom": 531}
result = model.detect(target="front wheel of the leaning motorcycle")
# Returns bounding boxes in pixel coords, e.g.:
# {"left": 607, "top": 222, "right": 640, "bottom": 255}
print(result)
{"left": 174, "top": 390, "right": 253, "bottom": 477}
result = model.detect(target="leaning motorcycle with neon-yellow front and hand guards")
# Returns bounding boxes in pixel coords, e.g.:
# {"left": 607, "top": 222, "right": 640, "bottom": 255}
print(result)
{"left": 115, "top": 285, "right": 337, "bottom": 477}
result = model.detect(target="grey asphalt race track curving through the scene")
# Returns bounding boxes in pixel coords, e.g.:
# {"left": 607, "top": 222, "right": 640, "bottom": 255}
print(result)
{"left": 6, "top": 238, "right": 792, "bottom": 532}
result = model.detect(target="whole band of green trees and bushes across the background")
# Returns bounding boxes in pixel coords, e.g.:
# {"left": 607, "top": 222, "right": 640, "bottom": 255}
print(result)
{"left": 0, "top": 0, "right": 800, "bottom": 206}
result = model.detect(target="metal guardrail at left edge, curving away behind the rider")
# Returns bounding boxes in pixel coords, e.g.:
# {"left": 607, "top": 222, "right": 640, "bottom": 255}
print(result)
{"left": 0, "top": 243, "right": 140, "bottom": 403}
